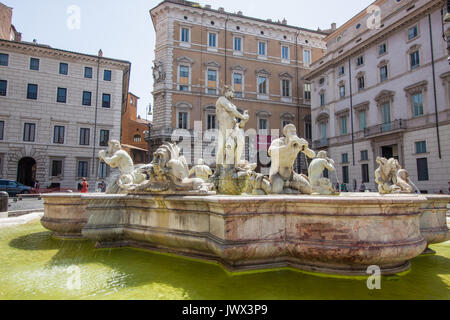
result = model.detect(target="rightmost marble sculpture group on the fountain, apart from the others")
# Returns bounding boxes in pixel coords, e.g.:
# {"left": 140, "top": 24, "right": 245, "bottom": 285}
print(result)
{"left": 375, "top": 157, "right": 413, "bottom": 194}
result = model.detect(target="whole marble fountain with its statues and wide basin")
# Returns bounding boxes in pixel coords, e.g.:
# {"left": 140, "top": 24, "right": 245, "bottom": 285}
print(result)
{"left": 41, "top": 88, "right": 450, "bottom": 276}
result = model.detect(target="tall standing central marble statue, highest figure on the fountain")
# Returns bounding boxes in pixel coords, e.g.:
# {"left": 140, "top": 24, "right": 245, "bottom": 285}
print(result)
{"left": 216, "top": 86, "right": 249, "bottom": 166}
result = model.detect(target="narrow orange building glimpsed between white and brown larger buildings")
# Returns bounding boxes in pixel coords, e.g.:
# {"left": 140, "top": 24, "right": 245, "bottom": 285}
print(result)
{"left": 121, "top": 92, "right": 150, "bottom": 164}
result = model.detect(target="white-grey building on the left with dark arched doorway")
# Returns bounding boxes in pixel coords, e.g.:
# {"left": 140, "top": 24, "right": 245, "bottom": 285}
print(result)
{"left": 0, "top": 40, "right": 131, "bottom": 190}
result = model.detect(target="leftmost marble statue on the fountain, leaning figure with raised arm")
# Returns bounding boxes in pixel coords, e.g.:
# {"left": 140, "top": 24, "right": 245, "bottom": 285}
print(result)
{"left": 98, "top": 140, "right": 145, "bottom": 193}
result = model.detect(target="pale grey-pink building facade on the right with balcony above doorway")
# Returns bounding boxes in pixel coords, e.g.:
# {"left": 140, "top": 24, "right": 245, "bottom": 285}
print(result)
{"left": 307, "top": 0, "right": 450, "bottom": 193}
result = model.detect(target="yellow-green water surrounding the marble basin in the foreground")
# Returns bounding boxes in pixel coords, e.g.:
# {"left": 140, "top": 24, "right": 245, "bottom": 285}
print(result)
{"left": 0, "top": 222, "right": 450, "bottom": 300}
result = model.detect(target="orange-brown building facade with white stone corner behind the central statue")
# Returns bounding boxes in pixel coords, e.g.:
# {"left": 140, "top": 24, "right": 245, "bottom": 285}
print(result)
{"left": 150, "top": 1, "right": 326, "bottom": 170}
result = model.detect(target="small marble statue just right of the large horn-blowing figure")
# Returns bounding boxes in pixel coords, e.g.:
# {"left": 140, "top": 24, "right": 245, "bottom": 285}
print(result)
{"left": 308, "top": 151, "right": 336, "bottom": 195}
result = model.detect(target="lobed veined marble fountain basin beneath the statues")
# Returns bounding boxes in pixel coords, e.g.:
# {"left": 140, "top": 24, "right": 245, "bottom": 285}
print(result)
{"left": 41, "top": 193, "right": 450, "bottom": 276}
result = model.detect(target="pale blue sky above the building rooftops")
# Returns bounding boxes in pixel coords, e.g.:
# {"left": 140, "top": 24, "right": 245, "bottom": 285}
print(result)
{"left": 0, "top": 0, "right": 373, "bottom": 119}
